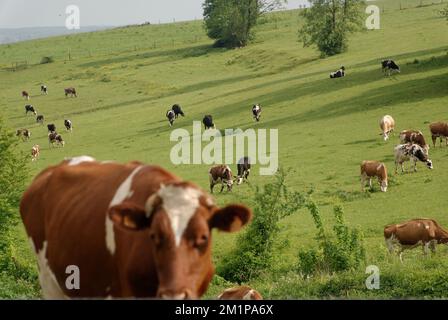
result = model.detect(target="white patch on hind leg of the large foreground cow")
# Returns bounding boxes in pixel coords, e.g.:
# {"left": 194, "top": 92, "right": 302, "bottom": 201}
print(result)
{"left": 30, "top": 238, "right": 68, "bottom": 300}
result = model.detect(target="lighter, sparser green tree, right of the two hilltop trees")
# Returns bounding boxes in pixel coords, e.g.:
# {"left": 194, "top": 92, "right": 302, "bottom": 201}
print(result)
{"left": 299, "top": 0, "right": 364, "bottom": 57}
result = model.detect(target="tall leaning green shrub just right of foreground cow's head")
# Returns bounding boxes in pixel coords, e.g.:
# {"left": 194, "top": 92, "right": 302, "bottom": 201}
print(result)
{"left": 217, "top": 171, "right": 306, "bottom": 283}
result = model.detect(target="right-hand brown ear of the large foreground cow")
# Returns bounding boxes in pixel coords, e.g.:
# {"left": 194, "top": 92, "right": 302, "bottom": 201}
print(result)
{"left": 210, "top": 205, "right": 252, "bottom": 232}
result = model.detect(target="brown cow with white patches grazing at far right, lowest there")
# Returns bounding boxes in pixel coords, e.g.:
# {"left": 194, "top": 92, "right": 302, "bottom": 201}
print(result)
{"left": 384, "top": 219, "right": 448, "bottom": 262}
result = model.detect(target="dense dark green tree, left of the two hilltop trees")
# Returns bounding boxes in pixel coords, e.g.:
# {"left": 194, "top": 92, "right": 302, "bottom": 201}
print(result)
{"left": 203, "top": 0, "right": 286, "bottom": 48}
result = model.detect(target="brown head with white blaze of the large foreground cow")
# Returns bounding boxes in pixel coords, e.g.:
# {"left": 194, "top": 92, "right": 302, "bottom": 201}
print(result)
{"left": 109, "top": 183, "right": 252, "bottom": 299}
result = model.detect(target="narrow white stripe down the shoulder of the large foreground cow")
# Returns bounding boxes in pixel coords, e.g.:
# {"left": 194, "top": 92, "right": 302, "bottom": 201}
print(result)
{"left": 106, "top": 166, "right": 143, "bottom": 255}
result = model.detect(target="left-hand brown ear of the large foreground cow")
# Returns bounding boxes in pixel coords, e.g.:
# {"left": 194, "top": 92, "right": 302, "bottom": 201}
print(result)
{"left": 108, "top": 202, "right": 151, "bottom": 231}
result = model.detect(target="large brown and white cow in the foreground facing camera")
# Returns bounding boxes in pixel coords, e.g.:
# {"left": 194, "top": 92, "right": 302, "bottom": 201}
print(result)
{"left": 20, "top": 157, "right": 252, "bottom": 299}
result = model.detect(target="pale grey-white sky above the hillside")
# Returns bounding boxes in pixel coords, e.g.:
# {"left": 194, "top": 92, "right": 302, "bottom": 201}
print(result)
{"left": 0, "top": 0, "right": 307, "bottom": 28}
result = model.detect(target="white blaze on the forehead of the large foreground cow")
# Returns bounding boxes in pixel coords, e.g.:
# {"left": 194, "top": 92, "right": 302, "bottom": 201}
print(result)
{"left": 157, "top": 185, "right": 203, "bottom": 246}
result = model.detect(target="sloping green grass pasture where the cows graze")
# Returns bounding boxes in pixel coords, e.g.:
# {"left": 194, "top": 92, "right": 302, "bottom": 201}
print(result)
{"left": 0, "top": 0, "right": 448, "bottom": 299}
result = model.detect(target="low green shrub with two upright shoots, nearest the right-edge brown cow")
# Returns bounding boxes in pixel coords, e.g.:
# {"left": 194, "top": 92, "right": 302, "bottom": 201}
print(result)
{"left": 298, "top": 200, "right": 365, "bottom": 277}
